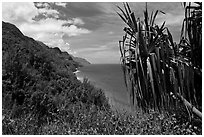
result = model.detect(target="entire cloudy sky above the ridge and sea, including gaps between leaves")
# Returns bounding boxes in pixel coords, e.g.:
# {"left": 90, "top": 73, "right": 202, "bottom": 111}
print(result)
{"left": 2, "top": 2, "right": 184, "bottom": 64}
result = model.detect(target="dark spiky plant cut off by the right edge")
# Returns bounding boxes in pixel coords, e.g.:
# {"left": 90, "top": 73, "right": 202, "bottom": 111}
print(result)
{"left": 179, "top": 2, "right": 202, "bottom": 107}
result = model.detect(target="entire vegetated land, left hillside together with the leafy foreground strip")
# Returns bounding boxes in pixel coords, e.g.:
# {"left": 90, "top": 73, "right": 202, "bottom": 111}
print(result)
{"left": 2, "top": 22, "right": 201, "bottom": 134}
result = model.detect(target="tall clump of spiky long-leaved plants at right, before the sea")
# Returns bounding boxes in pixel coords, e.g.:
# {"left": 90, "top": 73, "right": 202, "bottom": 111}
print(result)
{"left": 117, "top": 3, "right": 202, "bottom": 117}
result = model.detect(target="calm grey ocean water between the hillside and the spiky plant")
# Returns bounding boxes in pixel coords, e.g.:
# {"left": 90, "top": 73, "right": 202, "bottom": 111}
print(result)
{"left": 75, "top": 64, "right": 131, "bottom": 111}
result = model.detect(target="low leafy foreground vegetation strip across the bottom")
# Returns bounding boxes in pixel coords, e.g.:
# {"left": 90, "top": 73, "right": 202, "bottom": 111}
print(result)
{"left": 3, "top": 99, "right": 202, "bottom": 135}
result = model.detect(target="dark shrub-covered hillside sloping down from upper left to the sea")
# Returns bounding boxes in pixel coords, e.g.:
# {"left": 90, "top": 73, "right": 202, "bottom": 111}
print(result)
{"left": 2, "top": 22, "right": 110, "bottom": 134}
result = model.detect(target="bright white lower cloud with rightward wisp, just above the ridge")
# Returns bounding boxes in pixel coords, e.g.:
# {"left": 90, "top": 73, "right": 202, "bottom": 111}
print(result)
{"left": 20, "top": 18, "right": 90, "bottom": 54}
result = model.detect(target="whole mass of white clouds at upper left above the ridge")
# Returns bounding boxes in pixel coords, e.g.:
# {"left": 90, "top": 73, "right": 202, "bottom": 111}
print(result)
{"left": 2, "top": 2, "right": 90, "bottom": 54}
